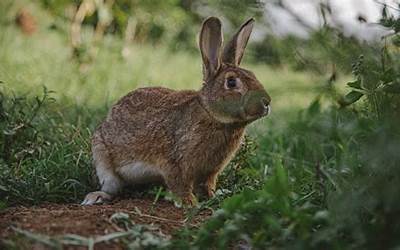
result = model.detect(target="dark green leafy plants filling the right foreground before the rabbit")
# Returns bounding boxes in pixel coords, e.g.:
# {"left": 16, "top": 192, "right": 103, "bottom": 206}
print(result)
{"left": 172, "top": 4, "right": 400, "bottom": 249}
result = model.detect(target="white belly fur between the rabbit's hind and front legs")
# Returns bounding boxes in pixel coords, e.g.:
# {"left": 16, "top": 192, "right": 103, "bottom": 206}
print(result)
{"left": 117, "top": 161, "right": 162, "bottom": 184}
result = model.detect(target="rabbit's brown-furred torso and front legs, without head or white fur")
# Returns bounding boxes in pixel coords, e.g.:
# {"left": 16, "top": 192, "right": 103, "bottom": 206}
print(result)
{"left": 93, "top": 88, "right": 244, "bottom": 200}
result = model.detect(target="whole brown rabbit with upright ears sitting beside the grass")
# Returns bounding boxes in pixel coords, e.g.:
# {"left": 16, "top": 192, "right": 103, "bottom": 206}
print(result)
{"left": 82, "top": 17, "right": 271, "bottom": 205}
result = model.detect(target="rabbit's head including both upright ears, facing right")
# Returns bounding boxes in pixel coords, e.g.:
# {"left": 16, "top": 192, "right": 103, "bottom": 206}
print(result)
{"left": 200, "top": 17, "right": 271, "bottom": 123}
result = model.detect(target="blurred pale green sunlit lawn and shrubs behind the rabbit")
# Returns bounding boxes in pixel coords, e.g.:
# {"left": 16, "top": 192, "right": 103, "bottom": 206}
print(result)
{"left": 1, "top": 1, "right": 358, "bottom": 110}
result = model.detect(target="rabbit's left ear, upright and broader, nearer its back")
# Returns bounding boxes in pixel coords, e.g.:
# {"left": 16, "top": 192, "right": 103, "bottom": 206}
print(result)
{"left": 199, "top": 17, "right": 222, "bottom": 81}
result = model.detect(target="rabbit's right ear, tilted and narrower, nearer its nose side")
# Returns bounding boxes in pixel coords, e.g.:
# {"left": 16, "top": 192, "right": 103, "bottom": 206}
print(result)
{"left": 222, "top": 18, "right": 254, "bottom": 66}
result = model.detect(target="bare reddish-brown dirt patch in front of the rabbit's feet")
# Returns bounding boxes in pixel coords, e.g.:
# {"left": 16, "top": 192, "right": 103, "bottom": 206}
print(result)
{"left": 0, "top": 199, "right": 211, "bottom": 249}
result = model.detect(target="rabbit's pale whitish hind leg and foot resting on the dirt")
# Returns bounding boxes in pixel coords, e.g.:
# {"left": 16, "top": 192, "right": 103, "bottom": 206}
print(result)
{"left": 81, "top": 148, "right": 123, "bottom": 205}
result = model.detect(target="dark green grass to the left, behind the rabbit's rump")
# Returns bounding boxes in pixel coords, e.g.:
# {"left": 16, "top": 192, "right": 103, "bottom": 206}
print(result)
{"left": 0, "top": 89, "right": 92, "bottom": 206}
